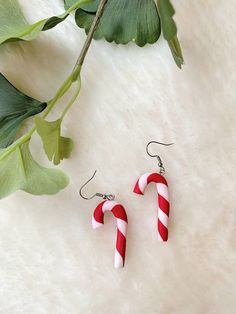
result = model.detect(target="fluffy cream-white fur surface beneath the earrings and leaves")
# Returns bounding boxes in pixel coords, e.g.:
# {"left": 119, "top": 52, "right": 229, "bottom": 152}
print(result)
{"left": 0, "top": 0, "right": 236, "bottom": 314}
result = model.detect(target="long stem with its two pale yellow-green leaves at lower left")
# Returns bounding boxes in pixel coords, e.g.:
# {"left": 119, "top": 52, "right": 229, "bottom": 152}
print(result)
{"left": 0, "top": 0, "right": 107, "bottom": 198}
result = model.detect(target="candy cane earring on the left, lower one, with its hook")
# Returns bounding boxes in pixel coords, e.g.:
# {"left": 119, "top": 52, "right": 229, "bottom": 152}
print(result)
{"left": 79, "top": 171, "right": 128, "bottom": 268}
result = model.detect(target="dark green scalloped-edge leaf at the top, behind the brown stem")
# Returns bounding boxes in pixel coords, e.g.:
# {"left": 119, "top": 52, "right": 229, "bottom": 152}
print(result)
{"left": 74, "top": 0, "right": 161, "bottom": 47}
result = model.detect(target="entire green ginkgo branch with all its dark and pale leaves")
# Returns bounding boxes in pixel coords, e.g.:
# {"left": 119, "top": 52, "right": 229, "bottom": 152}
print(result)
{"left": 0, "top": 0, "right": 184, "bottom": 198}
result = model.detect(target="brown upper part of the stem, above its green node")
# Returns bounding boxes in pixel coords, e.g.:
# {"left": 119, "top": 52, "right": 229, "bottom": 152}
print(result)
{"left": 76, "top": 0, "right": 108, "bottom": 67}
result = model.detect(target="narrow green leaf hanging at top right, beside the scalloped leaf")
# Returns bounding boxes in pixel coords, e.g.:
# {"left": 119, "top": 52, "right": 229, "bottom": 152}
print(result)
{"left": 157, "top": 0, "right": 184, "bottom": 68}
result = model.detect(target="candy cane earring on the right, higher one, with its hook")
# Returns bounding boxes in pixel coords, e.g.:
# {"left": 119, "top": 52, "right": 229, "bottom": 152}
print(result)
{"left": 134, "top": 141, "right": 173, "bottom": 241}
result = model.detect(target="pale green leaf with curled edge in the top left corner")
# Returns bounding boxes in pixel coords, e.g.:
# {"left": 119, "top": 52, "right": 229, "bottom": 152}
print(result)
{"left": 0, "top": 0, "right": 91, "bottom": 44}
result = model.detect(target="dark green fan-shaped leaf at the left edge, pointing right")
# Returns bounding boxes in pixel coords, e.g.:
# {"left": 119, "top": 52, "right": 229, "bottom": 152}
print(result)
{"left": 0, "top": 73, "right": 47, "bottom": 148}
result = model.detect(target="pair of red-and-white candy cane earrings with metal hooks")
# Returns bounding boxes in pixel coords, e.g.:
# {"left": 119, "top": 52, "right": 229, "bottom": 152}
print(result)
{"left": 79, "top": 141, "right": 173, "bottom": 268}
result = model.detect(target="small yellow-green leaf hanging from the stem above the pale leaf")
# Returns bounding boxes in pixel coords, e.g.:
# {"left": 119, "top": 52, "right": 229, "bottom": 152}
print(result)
{"left": 35, "top": 117, "right": 73, "bottom": 165}
